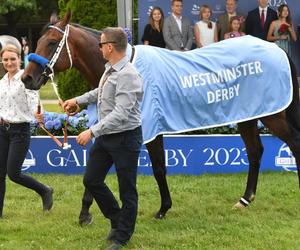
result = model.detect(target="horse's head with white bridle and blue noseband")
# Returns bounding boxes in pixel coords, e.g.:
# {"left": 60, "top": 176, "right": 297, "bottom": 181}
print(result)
{"left": 21, "top": 11, "right": 73, "bottom": 90}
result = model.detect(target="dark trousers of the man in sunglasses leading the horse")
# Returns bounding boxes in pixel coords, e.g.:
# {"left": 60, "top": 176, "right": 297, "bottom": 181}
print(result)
{"left": 83, "top": 127, "right": 142, "bottom": 244}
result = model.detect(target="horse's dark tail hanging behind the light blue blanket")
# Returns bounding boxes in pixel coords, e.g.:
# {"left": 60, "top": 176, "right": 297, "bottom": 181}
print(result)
{"left": 286, "top": 57, "right": 300, "bottom": 132}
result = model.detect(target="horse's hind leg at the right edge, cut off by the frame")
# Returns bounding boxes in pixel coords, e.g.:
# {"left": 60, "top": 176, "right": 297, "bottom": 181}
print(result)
{"left": 261, "top": 112, "right": 300, "bottom": 186}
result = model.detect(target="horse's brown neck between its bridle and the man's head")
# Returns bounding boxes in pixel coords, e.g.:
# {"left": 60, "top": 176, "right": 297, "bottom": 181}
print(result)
{"left": 74, "top": 28, "right": 105, "bottom": 87}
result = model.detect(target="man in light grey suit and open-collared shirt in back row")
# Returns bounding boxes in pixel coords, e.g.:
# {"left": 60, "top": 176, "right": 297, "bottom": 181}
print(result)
{"left": 163, "top": 0, "right": 193, "bottom": 51}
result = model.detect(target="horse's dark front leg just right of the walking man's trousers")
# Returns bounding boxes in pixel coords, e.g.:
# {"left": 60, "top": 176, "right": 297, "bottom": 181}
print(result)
{"left": 146, "top": 135, "right": 172, "bottom": 219}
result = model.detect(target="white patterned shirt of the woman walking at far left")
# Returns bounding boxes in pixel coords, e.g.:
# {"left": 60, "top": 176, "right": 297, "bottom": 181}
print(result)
{"left": 0, "top": 70, "right": 39, "bottom": 123}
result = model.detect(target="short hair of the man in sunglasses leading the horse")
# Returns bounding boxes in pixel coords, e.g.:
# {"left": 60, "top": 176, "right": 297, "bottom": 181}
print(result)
{"left": 102, "top": 27, "right": 127, "bottom": 52}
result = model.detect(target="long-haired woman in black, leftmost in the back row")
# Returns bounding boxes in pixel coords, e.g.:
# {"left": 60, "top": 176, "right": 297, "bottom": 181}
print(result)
{"left": 142, "top": 7, "right": 166, "bottom": 48}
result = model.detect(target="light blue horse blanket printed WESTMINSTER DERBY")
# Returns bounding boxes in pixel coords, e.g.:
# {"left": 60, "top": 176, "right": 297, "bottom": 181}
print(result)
{"left": 133, "top": 36, "right": 292, "bottom": 143}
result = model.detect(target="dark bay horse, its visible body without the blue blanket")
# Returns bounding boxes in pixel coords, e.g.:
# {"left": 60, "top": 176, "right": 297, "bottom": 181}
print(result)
{"left": 22, "top": 12, "right": 300, "bottom": 223}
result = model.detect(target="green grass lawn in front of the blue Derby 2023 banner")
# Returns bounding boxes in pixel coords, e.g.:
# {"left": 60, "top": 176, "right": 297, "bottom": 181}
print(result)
{"left": 0, "top": 172, "right": 300, "bottom": 250}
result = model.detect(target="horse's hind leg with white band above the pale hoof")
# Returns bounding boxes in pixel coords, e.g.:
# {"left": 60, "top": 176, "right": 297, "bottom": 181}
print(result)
{"left": 234, "top": 120, "right": 264, "bottom": 208}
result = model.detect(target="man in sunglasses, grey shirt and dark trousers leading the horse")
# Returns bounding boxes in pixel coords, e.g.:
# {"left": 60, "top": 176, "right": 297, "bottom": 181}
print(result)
{"left": 64, "top": 28, "right": 143, "bottom": 249}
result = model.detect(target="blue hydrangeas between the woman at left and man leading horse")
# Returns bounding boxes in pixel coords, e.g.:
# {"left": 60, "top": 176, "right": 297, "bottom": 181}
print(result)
{"left": 30, "top": 109, "right": 89, "bottom": 135}
